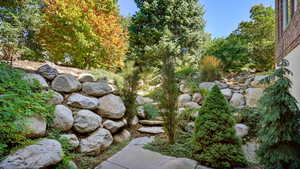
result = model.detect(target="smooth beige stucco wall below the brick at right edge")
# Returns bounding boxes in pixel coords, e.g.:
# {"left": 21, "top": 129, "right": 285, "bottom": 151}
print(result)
{"left": 286, "top": 45, "right": 300, "bottom": 105}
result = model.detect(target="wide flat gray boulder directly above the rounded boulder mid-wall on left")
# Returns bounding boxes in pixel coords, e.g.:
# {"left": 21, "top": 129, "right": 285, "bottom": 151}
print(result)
{"left": 67, "top": 93, "right": 99, "bottom": 110}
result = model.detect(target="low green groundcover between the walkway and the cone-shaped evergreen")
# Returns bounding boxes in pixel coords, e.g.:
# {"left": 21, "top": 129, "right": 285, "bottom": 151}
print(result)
{"left": 144, "top": 132, "right": 193, "bottom": 159}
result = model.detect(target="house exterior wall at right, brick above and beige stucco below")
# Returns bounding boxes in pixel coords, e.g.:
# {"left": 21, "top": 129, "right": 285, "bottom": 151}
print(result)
{"left": 276, "top": 0, "right": 300, "bottom": 105}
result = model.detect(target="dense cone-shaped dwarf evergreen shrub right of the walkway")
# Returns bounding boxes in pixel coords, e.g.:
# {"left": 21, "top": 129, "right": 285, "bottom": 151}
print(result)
{"left": 192, "top": 86, "right": 246, "bottom": 169}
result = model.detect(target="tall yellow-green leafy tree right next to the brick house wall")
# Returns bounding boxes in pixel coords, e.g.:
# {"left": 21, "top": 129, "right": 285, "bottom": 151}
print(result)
{"left": 238, "top": 4, "right": 276, "bottom": 71}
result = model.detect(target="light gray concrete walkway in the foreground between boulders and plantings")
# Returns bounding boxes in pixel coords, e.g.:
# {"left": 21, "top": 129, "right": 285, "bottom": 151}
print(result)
{"left": 95, "top": 137, "right": 206, "bottom": 169}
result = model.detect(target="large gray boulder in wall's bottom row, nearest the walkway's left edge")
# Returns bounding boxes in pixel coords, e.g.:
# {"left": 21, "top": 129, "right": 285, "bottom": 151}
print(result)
{"left": 79, "top": 128, "right": 113, "bottom": 155}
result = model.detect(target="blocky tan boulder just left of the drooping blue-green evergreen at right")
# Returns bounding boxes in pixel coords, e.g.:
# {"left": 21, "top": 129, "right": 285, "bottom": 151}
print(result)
{"left": 246, "top": 88, "right": 264, "bottom": 107}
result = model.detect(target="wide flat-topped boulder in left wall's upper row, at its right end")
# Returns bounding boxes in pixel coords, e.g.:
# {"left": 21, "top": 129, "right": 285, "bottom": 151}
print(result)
{"left": 82, "top": 82, "right": 113, "bottom": 97}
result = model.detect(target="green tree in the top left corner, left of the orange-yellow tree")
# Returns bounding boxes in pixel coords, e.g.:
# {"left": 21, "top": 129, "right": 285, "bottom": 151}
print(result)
{"left": 0, "top": 0, "right": 42, "bottom": 60}
